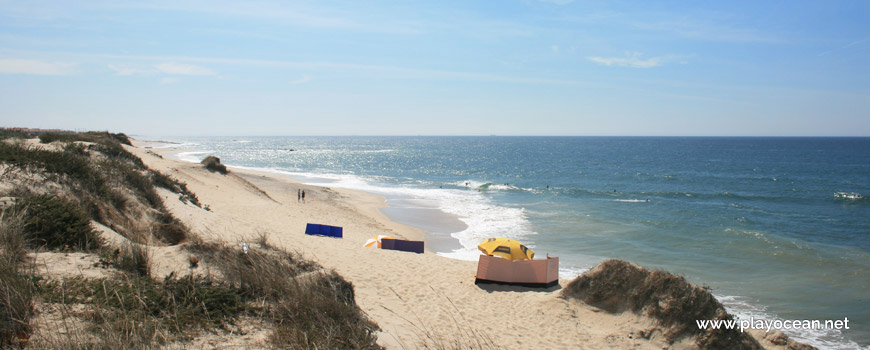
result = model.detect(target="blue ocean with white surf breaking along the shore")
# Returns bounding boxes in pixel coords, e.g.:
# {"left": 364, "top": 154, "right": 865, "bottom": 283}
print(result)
{"left": 152, "top": 136, "right": 870, "bottom": 349}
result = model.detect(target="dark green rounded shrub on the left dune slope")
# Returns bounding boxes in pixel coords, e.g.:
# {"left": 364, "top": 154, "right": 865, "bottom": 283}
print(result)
{"left": 15, "top": 195, "right": 103, "bottom": 250}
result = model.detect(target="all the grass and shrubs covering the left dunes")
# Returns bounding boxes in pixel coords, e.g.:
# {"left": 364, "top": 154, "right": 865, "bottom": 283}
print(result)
{"left": 0, "top": 130, "right": 381, "bottom": 349}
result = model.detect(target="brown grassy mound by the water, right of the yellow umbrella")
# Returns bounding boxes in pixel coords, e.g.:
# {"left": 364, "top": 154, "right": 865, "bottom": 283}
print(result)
{"left": 562, "top": 259, "right": 761, "bottom": 349}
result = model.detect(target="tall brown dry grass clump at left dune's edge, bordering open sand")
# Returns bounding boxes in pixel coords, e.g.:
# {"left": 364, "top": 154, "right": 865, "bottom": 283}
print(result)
{"left": 190, "top": 241, "right": 381, "bottom": 349}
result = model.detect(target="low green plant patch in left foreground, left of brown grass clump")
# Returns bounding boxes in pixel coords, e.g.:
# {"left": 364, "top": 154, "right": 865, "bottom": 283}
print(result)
{"left": 39, "top": 275, "right": 245, "bottom": 348}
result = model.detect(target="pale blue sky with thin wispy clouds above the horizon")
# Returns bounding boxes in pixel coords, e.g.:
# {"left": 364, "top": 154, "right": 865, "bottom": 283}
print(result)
{"left": 0, "top": 0, "right": 870, "bottom": 136}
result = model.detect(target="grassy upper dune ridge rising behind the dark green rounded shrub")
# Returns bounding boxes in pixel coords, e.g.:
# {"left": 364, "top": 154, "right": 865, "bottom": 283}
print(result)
{"left": 0, "top": 132, "right": 194, "bottom": 247}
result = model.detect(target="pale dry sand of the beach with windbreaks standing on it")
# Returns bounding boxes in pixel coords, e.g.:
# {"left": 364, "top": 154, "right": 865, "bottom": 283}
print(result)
{"left": 114, "top": 142, "right": 796, "bottom": 349}
